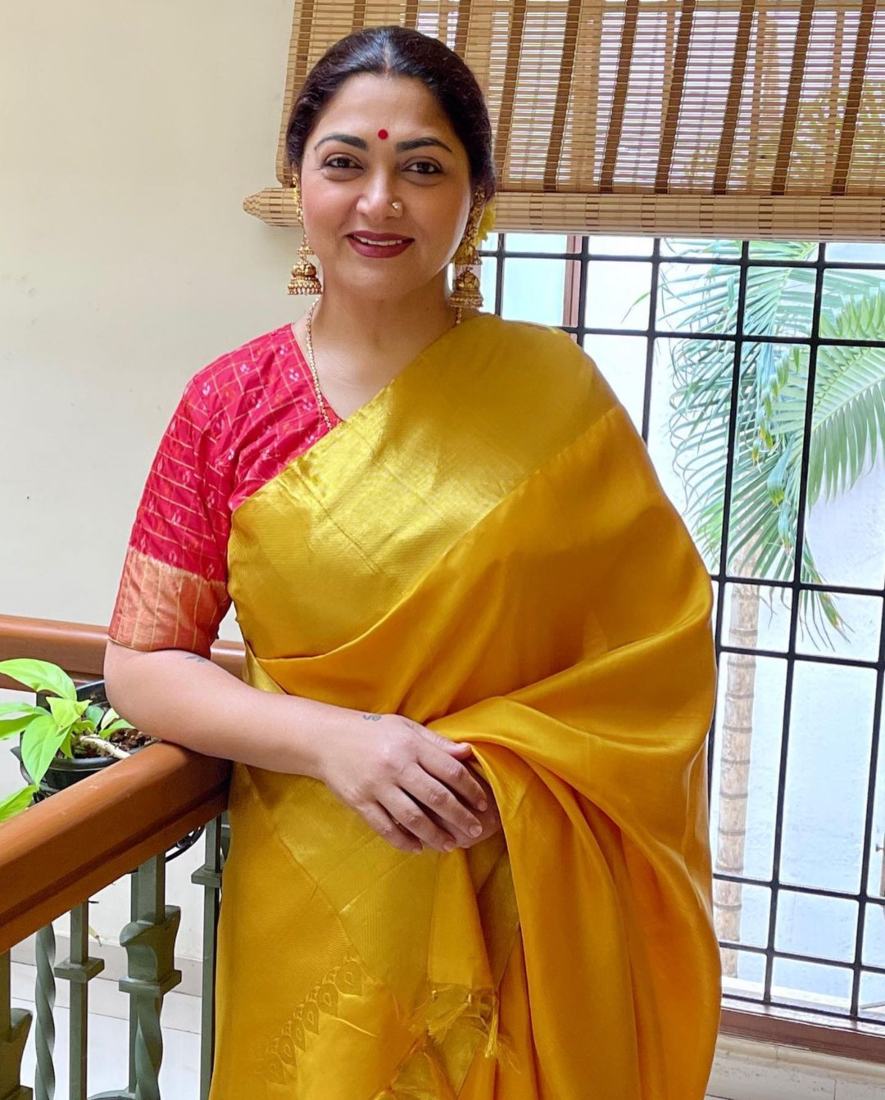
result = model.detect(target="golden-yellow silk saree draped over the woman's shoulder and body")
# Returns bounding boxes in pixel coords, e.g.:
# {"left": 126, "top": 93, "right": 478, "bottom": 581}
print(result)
{"left": 211, "top": 315, "right": 719, "bottom": 1100}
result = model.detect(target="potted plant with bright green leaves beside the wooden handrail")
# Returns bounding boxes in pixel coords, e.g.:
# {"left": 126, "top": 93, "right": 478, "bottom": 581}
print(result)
{"left": 0, "top": 658, "right": 153, "bottom": 822}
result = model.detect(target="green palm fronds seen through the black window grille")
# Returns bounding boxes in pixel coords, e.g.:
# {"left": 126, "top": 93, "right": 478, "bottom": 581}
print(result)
{"left": 661, "top": 241, "right": 885, "bottom": 645}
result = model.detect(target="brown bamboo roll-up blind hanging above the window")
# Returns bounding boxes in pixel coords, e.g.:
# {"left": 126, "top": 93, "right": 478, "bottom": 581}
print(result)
{"left": 244, "top": 0, "right": 885, "bottom": 240}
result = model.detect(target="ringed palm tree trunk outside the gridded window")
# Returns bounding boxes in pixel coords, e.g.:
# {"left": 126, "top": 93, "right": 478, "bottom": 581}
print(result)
{"left": 713, "top": 561, "right": 759, "bottom": 977}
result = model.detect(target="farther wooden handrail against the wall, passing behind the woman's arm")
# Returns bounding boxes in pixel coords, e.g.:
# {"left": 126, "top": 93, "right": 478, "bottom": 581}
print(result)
{"left": 0, "top": 615, "right": 244, "bottom": 689}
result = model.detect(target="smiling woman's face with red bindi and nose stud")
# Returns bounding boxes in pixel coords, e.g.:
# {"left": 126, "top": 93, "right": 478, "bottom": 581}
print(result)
{"left": 301, "top": 73, "right": 471, "bottom": 299}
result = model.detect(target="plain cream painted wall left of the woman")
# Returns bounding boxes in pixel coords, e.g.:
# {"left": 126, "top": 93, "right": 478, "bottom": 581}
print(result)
{"left": 0, "top": 0, "right": 301, "bottom": 638}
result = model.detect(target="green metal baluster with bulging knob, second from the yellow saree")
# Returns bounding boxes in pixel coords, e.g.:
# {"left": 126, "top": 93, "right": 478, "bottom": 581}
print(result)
{"left": 92, "top": 856, "right": 181, "bottom": 1100}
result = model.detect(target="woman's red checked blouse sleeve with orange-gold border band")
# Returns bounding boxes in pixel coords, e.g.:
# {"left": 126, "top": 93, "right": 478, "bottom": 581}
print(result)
{"left": 108, "top": 380, "right": 231, "bottom": 657}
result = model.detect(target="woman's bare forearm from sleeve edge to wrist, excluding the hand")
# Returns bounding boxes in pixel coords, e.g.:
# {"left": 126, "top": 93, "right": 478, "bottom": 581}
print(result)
{"left": 104, "top": 642, "right": 359, "bottom": 778}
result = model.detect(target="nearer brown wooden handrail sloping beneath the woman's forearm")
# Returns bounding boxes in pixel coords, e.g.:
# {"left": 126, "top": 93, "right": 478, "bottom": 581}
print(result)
{"left": 0, "top": 743, "right": 231, "bottom": 953}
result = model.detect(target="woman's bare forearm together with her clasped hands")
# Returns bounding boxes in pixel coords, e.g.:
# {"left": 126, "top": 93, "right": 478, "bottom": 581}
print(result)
{"left": 104, "top": 641, "right": 500, "bottom": 851}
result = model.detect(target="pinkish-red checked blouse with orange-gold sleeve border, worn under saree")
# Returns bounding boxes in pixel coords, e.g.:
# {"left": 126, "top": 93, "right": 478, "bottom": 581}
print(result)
{"left": 108, "top": 325, "right": 339, "bottom": 657}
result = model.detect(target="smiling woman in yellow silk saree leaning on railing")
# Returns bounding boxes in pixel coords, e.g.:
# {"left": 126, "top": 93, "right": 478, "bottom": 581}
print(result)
{"left": 106, "top": 28, "right": 719, "bottom": 1100}
